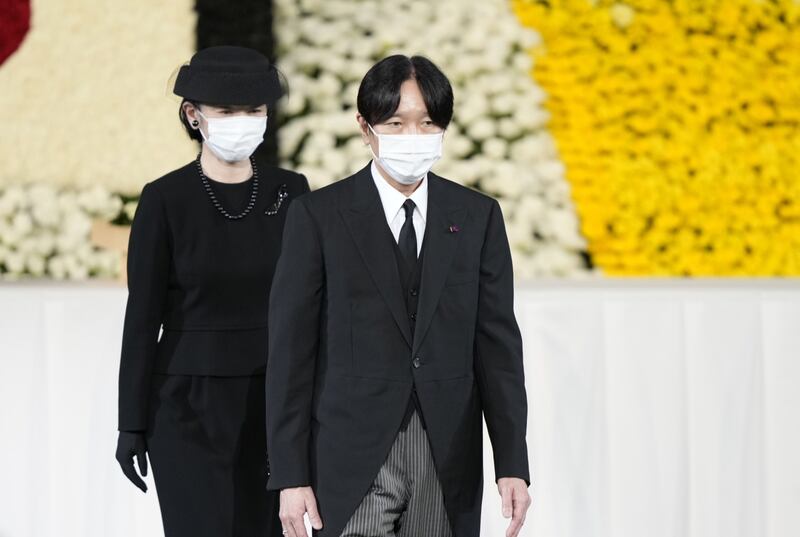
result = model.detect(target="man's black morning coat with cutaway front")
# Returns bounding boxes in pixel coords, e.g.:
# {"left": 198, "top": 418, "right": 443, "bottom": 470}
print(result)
{"left": 266, "top": 166, "right": 529, "bottom": 537}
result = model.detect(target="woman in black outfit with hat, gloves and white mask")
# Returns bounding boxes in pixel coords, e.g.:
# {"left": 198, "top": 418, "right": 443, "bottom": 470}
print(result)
{"left": 117, "top": 47, "right": 309, "bottom": 537}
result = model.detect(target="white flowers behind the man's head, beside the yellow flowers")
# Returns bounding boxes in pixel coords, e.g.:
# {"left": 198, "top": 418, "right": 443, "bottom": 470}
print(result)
{"left": 275, "top": 0, "right": 591, "bottom": 279}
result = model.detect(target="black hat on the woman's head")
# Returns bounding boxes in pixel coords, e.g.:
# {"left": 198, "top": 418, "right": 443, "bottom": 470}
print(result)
{"left": 173, "top": 46, "right": 283, "bottom": 105}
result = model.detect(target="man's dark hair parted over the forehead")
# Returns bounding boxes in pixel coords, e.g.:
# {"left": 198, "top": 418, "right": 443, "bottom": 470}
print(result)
{"left": 357, "top": 54, "right": 453, "bottom": 129}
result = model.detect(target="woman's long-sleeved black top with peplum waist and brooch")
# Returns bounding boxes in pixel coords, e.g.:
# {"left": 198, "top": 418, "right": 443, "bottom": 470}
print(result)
{"left": 119, "top": 162, "right": 309, "bottom": 431}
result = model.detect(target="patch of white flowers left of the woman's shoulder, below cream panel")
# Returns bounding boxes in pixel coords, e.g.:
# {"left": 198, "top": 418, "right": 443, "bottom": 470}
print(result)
{"left": 0, "top": 184, "right": 127, "bottom": 280}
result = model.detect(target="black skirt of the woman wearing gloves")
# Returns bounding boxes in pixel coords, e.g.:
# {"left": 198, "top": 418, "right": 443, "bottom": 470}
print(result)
{"left": 147, "top": 375, "right": 281, "bottom": 537}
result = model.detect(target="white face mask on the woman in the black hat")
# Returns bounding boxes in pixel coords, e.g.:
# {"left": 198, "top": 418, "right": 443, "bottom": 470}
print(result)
{"left": 197, "top": 110, "right": 267, "bottom": 162}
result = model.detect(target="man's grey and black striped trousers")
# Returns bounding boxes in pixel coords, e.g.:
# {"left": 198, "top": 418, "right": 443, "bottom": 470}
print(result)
{"left": 341, "top": 412, "right": 452, "bottom": 537}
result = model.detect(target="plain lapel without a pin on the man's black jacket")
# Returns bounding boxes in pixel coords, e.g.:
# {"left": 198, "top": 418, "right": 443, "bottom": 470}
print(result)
{"left": 340, "top": 165, "right": 412, "bottom": 347}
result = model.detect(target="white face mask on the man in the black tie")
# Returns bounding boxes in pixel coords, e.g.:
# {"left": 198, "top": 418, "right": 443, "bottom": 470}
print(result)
{"left": 368, "top": 124, "right": 444, "bottom": 185}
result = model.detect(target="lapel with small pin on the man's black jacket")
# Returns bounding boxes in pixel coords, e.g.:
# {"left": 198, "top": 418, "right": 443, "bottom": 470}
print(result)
{"left": 411, "top": 173, "right": 465, "bottom": 355}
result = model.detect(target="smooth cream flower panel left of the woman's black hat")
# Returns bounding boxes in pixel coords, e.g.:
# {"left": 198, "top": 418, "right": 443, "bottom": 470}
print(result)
{"left": 0, "top": 0, "right": 197, "bottom": 194}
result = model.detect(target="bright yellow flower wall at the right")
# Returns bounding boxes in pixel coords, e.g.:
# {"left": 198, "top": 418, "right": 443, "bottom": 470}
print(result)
{"left": 512, "top": 0, "right": 800, "bottom": 276}
